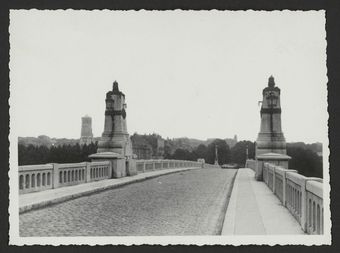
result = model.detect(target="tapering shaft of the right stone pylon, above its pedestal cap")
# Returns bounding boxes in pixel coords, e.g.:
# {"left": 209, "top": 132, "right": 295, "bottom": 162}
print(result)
{"left": 256, "top": 76, "right": 287, "bottom": 156}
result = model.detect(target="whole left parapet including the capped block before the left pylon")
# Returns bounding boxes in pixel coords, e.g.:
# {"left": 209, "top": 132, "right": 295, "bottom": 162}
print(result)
{"left": 19, "top": 159, "right": 202, "bottom": 194}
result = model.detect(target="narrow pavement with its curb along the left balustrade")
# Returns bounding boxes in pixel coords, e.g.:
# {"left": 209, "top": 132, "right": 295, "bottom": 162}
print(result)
{"left": 19, "top": 167, "right": 197, "bottom": 213}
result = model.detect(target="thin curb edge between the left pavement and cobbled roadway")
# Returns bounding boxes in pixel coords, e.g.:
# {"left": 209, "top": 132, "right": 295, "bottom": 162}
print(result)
{"left": 19, "top": 167, "right": 199, "bottom": 214}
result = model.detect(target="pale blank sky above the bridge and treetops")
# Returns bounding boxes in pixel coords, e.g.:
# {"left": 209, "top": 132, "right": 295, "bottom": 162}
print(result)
{"left": 9, "top": 10, "right": 328, "bottom": 143}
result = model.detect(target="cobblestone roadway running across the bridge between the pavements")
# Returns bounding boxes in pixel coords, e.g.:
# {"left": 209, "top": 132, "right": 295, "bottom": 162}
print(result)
{"left": 19, "top": 169, "right": 236, "bottom": 236}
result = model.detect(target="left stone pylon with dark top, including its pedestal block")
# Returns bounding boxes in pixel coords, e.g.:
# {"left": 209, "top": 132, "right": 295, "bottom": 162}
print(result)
{"left": 90, "top": 81, "right": 137, "bottom": 178}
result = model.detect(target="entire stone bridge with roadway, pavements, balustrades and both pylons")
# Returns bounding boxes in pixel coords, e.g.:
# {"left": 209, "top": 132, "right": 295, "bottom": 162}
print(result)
{"left": 18, "top": 77, "right": 324, "bottom": 236}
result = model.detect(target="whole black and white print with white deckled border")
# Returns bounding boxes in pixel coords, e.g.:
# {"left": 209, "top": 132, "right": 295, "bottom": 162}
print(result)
{"left": 8, "top": 9, "right": 331, "bottom": 245}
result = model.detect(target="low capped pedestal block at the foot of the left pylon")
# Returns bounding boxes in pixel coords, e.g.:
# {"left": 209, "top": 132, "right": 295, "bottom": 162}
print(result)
{"left": 89, "top": 152, "right": 127, "bottom": 178}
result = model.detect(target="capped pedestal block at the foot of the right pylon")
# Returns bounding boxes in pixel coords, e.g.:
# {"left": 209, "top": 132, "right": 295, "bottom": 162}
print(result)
{"left": 255, "top": 153, "right": 291, "bottom": 181}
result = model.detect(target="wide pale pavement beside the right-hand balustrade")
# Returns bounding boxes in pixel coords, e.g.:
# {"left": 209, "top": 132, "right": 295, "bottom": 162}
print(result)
{"left": 222, "top": 168, "right": 304, "bottom": 235}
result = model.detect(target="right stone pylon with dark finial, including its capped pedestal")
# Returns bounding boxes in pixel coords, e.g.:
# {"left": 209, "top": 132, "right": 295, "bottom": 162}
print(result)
{"left": 255, "top": 76, "right": 290, "bottom": 180}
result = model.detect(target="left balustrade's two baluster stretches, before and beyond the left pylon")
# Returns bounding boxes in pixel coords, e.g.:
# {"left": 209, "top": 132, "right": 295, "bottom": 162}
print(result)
{"left": 19, "top": 160, "right": 203, "bottom": 194}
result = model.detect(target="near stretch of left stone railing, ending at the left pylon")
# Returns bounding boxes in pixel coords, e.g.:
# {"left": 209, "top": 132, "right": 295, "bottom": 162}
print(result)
{"left": 19, "top": 161, "right": 111, "bottom": 194}
